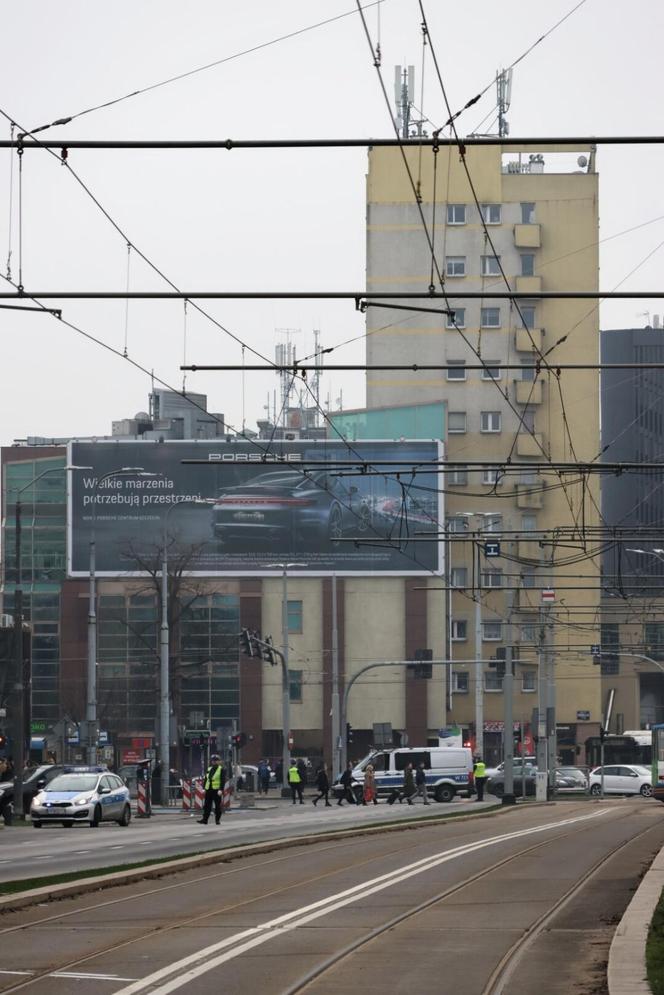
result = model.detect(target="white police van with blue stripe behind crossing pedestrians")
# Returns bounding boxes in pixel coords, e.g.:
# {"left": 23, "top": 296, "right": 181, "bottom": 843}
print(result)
{"left": 353, "top": 746, "right": 475, "bottom": 802}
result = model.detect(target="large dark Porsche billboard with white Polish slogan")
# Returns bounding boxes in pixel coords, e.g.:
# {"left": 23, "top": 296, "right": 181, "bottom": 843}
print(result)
{"left": 67, "top": 440, "right": 444, "bottom": 577}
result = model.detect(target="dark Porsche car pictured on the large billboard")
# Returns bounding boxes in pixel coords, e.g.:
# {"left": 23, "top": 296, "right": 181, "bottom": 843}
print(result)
{"left": 212, "top": 470, "right": 373, "bottom": 549}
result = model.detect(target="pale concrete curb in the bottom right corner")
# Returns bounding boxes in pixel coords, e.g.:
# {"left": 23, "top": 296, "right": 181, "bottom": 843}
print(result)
{"left": 607, "top": 848, "right": 664, "bottom": 995}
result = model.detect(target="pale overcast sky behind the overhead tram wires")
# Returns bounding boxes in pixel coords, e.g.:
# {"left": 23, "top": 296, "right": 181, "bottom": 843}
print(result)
{"left": 0, "top": 0, "right": 664, "bottom": 444}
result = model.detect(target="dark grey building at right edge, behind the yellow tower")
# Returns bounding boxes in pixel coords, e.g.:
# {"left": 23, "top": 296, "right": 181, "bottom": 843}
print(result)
{"left": 600, "top": 315, "right": 664, "bottom": 732}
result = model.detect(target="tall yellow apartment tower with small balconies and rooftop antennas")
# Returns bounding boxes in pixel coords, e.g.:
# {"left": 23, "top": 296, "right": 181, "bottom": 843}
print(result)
{"left": 366, "top": 146, "right": 602, "bottom": 758}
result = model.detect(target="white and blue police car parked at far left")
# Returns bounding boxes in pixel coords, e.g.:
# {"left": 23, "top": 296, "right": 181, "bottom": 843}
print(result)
{"left": 30, "top": 767, "right": 131, "bottom": 829}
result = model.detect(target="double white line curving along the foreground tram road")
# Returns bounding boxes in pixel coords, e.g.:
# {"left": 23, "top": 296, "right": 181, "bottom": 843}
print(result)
{"left": 115, "top": 809, "right": 611, "bottom": 995}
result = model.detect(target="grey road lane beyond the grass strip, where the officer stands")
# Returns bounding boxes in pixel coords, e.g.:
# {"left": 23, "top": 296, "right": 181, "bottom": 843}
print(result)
{"left": 0, "top": 797, "right": 496, "bottom": 882}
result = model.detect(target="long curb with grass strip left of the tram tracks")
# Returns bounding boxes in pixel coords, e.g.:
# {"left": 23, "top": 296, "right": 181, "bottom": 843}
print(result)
{"left": 0, "top": 803, "right": 506, "bottom": 915}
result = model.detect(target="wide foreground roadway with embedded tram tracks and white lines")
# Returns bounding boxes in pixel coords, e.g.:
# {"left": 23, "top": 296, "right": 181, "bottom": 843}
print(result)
{"left": 0, "top": 799, "right": 664, "bottom": 995}
